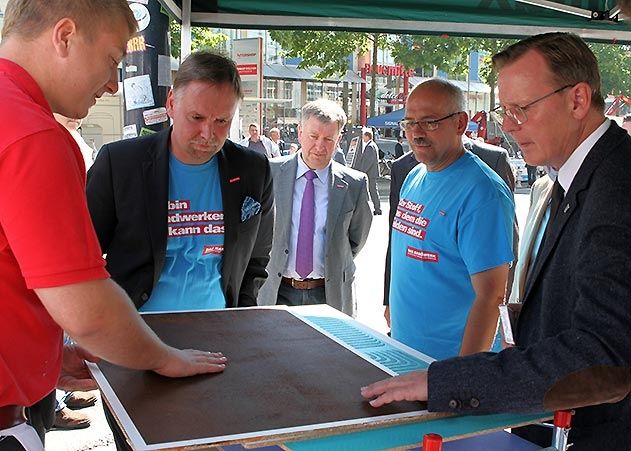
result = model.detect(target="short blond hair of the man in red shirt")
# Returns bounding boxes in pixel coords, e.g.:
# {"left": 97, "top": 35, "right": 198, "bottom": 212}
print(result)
{"left": 2, "top": 0, "right": 138, "bottom": 39}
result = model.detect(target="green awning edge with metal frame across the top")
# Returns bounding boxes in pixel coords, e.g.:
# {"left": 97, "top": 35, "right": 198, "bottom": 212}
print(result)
{"left": 160, "top": 0, "right": 631, "bottom": 43}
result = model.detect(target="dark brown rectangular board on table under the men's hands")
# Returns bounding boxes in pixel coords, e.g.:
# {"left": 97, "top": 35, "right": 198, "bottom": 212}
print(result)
{"left": 99, "top": 308, "right": 432, "bottom": 445}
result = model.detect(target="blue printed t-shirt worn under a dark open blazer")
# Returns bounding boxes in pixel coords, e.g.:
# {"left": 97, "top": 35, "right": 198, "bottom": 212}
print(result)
{"left": 140, "top": 154, "right": 226, "bottom": 312}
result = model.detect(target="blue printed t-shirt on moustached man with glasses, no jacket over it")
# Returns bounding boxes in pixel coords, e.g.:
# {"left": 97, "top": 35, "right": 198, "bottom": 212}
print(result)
{"left": 390, "top": 152, "right": 515, "bottom": 359}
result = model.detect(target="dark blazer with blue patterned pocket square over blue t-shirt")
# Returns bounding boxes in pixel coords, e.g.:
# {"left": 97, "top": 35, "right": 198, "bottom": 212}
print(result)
{"left": 87, "top": 129, "right": 274, "bottom": 307}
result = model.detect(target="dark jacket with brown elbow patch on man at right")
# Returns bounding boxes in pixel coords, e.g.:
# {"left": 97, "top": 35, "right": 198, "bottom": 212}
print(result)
{"left": 428, "top": 122, "right": 631, "bottom": 451}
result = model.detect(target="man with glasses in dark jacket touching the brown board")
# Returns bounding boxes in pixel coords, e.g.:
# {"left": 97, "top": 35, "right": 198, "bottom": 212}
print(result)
{"left": 362, "top": 33, "right": 631, "bottom": 451}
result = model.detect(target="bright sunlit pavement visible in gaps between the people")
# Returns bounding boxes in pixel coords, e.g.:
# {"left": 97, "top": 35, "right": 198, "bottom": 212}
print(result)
{"left": 46, "top": 179, "right": 530, "bottom": 451}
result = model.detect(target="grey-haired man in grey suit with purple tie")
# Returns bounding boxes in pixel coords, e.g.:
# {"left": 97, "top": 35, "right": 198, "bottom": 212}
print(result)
{"left": 258, "top": 99, "right": 372, "bottom": 316}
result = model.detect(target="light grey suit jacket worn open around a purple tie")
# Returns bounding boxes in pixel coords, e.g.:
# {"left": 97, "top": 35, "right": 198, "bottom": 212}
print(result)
{"left": 258, "top": 152, "right": 372, "bottom": 316}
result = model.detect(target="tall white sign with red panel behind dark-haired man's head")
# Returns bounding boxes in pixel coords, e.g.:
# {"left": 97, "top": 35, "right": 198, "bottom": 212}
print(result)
{"left": 232, "top": 38, "right": 263, "bottom": 136}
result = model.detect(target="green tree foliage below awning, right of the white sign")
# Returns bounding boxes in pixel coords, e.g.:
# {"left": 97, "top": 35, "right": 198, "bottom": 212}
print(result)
{"left": 262, "top": 31, "right": 631, "bottom": 115}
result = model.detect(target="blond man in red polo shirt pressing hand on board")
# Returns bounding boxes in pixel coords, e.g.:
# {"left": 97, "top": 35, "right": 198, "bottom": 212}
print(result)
{"left": 0, "top": 0, "right": 226, "bottom": 450}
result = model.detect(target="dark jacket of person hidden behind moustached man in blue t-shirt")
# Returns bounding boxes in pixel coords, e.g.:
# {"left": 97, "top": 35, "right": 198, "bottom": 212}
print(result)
{"left": 383, "top": 138, "right": 519, "bottom": 305}
